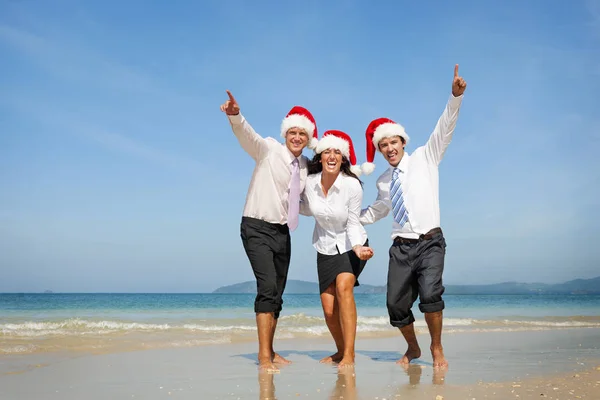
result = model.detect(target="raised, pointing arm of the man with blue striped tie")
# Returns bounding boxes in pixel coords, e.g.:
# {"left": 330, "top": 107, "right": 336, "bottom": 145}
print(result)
{"left": 425, "top": 64, "right": 467, "bottom": 165}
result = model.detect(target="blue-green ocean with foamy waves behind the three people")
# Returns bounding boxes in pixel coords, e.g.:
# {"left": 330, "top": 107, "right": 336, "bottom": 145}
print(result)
{"left": 0, "top": 293, "right": 600, "bottom": 355}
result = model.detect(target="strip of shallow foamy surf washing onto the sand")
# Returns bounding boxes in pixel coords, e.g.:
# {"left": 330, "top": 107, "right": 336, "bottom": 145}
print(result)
{"left": 0, "top": 313, "right": 600, "bottom": 360}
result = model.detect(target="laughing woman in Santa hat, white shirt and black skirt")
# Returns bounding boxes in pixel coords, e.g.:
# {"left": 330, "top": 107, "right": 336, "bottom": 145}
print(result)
{"left": 300, "top": 130, "right": 373, "bottom": 367}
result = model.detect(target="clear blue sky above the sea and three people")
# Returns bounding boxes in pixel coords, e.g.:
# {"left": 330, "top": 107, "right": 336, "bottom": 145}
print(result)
{"left": 0, "top": 0, "right": 600, "bottom": 292}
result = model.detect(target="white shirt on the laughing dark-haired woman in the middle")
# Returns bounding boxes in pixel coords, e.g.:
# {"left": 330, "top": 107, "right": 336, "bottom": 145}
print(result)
{"left": 300, "top": 173, "right": 367, "bottom": 255}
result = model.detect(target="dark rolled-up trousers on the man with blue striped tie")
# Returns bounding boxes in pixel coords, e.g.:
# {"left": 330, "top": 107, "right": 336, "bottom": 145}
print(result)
{"left": 387, "top": 231, "right": 446, "bottom": 328}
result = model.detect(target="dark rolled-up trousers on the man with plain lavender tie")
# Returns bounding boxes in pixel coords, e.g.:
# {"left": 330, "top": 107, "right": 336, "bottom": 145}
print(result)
{"left": 240, "top": 217, "right": 292, "bottom": 318}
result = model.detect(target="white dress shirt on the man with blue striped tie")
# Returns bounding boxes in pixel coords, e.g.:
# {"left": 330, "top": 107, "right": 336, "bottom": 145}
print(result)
{"left": 360, "top": 95, "right": 463, "bottom": 239}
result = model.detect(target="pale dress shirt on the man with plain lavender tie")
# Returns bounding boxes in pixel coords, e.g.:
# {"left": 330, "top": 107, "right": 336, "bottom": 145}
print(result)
{"left": 228, "top": 113, "right": 308, "bottom": 224}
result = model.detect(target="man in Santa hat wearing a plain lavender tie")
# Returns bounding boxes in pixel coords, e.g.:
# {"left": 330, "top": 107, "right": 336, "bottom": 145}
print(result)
{"left": 221, "top": 91, "right": 318, "bottom": 371}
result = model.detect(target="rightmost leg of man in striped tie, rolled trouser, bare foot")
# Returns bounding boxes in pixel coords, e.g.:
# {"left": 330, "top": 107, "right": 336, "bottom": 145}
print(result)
{"left": 417, "top": 234, "right": 448, "bottom": 368}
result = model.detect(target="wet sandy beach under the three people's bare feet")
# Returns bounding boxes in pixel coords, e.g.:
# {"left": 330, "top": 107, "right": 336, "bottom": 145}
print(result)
{"left": 0, "top": 328, "right": 600, "bottom": 400}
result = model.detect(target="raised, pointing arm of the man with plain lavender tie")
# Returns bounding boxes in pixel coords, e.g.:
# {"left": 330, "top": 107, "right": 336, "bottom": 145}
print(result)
{"left": 221, "top": 90, "right": 268, "bottom": 161}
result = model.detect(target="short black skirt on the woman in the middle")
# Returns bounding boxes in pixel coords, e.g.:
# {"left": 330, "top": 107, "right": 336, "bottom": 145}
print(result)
{"left": 317, "top": 239, "right": 369, "bottom": 293}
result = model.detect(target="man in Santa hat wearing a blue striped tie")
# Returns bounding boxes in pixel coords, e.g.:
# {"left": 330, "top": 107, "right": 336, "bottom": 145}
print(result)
{"left": 360, "top": 65, "right": 467, "bottom": 368}
